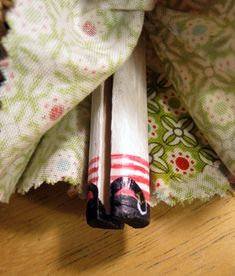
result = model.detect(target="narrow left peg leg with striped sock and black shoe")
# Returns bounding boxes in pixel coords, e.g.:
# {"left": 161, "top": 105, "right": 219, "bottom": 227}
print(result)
{"left": 87, "top": 79, "right": 123, "bottom": 229}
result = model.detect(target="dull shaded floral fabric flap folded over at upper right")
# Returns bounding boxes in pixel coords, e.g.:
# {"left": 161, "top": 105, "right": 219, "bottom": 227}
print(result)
{"left": 149, "top": 1, "right": 235, "bottom": 174}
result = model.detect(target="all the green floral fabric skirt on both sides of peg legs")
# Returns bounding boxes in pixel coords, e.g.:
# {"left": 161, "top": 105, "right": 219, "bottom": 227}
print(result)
{"left": 0, "top": 0, "right": 235, "bottom": 205}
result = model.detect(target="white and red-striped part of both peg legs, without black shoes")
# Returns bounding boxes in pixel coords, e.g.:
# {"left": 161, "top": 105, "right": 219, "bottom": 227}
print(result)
{"left": 88, "top": 33, "right": 149, "bottom": 208}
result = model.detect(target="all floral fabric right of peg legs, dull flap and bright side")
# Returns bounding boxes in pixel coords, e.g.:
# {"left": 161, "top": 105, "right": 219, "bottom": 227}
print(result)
{"left": 146, "top": 1, "right": 235, "bottom": 204}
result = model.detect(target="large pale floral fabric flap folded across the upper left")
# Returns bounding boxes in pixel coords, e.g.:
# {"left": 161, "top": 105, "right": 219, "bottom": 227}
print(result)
{"left": 0, "top": 0, "right": 144, "bottom": 201}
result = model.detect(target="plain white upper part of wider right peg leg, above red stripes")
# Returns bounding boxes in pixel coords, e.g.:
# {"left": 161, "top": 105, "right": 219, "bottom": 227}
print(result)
{"left": 112, "top": 34, "right": 148, "bottom": 160}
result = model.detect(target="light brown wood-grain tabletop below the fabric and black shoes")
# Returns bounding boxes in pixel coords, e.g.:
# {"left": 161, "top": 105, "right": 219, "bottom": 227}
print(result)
{"left": 0, "top": 185, "right": 235, "bottom": 276}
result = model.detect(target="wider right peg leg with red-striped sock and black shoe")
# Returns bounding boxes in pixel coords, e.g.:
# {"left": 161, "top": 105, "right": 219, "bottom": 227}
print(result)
{"left": 111, "top": 32, "right": 150, "bottom": 228}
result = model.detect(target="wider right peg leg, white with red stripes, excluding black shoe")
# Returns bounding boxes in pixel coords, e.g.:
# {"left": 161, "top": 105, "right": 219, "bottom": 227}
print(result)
{"left": 111, "top": 34, "right": 150, "bottom": 198}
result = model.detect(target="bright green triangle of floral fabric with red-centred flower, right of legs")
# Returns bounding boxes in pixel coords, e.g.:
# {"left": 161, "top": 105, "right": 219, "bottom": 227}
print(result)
{"left": 148, "top": 59, "right": 230, "bottom": 205}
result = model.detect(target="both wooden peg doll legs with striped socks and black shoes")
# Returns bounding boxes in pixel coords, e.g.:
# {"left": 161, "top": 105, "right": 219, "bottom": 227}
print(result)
{"left": 86, "top": 34, "right": 150, "bottom": 229}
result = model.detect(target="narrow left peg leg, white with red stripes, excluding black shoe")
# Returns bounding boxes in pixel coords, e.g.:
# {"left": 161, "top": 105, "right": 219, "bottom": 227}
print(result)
{"left": 88, "top": 83, "right": 111, "bottom": 211}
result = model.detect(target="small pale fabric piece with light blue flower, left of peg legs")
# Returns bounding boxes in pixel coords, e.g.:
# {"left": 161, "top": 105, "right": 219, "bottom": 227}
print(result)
{"left": 17, "top": 98, "right": 90, "bottom": 194}
